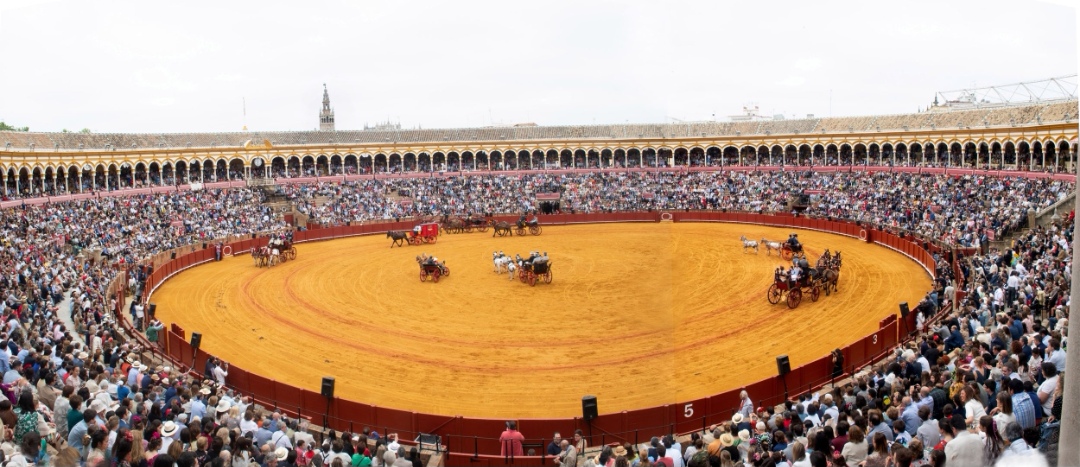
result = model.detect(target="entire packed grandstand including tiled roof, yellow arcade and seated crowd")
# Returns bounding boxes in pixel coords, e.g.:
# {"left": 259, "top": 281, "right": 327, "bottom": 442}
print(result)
{"left": 0, "top": 96, "right": 1077, "bottom": 466}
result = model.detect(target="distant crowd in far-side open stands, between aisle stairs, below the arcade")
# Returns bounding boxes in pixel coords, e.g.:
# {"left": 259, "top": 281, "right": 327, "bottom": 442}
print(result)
{"left": 285, "top": 171, "right": 1076, "bottom": 246}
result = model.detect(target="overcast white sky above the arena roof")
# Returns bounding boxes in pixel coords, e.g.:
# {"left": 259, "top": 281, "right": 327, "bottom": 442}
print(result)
{"left": 0, "top": 0, "right": 1077, "bottom": 133}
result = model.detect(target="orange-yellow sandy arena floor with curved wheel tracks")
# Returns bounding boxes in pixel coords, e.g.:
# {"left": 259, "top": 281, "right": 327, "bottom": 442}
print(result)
{"left": 153, "top": 223, "right": 930, "bottom": 418}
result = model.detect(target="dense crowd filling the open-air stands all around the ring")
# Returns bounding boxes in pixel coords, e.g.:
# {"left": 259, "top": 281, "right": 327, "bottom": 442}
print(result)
{"left": 0, "top": 168, "right": 1075, "bottom": 467}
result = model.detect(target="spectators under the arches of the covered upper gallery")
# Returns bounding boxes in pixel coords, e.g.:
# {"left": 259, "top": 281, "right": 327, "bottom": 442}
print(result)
{"left": 0, "top": 151, "right": 1072, "bottom": 200}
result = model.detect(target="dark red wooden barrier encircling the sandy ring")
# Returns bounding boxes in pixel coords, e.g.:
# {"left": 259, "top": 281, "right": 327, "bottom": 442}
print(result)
{"left": 135, "top": 211, "right": 941, "bottom": 465}
